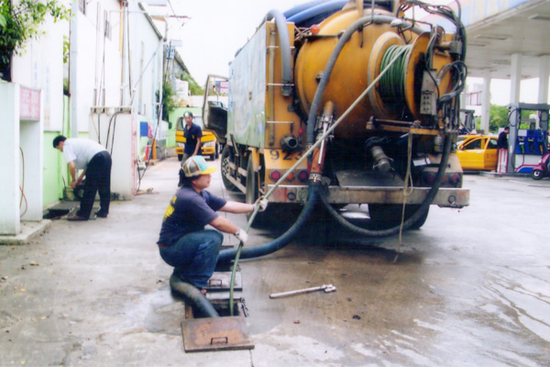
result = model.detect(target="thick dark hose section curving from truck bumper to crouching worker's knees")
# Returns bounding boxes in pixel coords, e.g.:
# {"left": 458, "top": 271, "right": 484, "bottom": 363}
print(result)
{"left": 218, "top": 181, "right": 320, "bottom": 264}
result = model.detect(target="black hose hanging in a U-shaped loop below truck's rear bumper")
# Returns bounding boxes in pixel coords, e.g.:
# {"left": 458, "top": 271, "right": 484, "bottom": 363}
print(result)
{"left": 320, "top": 137, "right": 452, "bottom": 237}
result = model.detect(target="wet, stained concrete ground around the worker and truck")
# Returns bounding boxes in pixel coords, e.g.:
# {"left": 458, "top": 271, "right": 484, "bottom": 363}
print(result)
{"left": 0, "top": 158, "right": 550, "bottom": 367}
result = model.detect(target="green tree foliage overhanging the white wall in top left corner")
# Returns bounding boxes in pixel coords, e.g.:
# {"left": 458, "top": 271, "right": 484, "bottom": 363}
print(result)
{"left": 0, "top": 0, "right": 70, "bottom": 80}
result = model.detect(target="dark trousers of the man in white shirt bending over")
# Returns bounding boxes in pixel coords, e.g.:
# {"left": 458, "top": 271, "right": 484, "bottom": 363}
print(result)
{"left": 76, "top": 150, "right": 112, "bottom": 218}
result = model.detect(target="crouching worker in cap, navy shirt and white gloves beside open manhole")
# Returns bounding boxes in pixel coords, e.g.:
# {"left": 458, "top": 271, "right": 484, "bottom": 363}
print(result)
{"left": 157, "top": 156, "right": 267, "bottom": 293}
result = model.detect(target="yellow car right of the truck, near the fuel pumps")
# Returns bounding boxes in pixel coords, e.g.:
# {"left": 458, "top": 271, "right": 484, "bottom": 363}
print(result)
{"left": 456, "top": 135, "right": 498, "bottom": 171}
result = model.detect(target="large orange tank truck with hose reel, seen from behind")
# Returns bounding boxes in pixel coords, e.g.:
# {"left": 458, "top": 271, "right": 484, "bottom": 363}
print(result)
{"left": 203, "top": 1, "right": 469, "bottom": 228}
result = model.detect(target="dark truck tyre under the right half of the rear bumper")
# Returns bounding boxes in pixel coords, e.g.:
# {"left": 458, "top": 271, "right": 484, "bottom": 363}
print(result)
{"left": 369, "top": 204, "right": 430, "bottom": 229}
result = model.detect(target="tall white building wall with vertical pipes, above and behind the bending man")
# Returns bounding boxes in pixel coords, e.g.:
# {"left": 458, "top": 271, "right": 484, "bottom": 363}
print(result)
{"left": 77, "top": 0, "right": 162, "bottom": 119}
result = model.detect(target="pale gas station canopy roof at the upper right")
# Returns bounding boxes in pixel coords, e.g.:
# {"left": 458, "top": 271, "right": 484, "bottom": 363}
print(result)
{"left": 462, "top": 0, "right": 550, "bottom": 79}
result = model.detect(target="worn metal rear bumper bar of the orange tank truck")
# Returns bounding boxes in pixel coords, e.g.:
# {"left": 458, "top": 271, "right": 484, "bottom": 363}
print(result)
{"left": 268, "top": 185, "right": 470, "bottom": 208}
